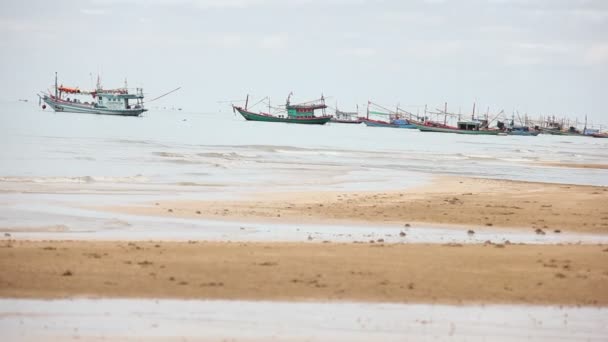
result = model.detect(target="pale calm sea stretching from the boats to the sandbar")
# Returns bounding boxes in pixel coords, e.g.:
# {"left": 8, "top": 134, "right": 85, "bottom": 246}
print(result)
{"left": 0, "top": 103, "right": 608, "bottom": 192}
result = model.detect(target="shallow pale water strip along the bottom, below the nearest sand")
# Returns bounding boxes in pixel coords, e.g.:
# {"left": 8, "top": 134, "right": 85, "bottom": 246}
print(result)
{"left": 0, "top": 299, "right": 608, "bottom": 341}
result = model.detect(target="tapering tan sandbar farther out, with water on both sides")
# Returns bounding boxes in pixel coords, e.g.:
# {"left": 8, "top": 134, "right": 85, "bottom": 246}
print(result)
{"left": 107, "top": 177, "right": 608, "bottom": 234}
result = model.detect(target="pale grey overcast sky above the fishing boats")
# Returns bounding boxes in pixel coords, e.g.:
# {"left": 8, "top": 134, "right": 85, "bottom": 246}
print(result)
{"left": 0, "top": 0, "right": 608, "bottom": 124}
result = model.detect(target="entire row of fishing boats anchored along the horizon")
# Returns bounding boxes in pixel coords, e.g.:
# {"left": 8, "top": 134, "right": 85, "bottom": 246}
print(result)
{"left": 38, "top": 74, "right": 608, "bottom": 138}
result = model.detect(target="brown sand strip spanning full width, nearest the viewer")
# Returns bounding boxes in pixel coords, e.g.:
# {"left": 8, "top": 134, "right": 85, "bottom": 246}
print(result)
{"left": 0, "top": 240, "right": 608, "bottom": 306}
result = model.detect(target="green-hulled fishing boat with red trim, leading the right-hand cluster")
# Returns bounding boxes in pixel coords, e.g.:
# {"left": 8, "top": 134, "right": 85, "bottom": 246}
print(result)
{"left": 232, "top": 93, "right": 332, "bottom": 125}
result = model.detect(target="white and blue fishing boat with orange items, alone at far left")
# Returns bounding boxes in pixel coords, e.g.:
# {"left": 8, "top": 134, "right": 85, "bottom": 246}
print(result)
{"left": 38, "top": 73, "right": 147, "bottom": 116}
